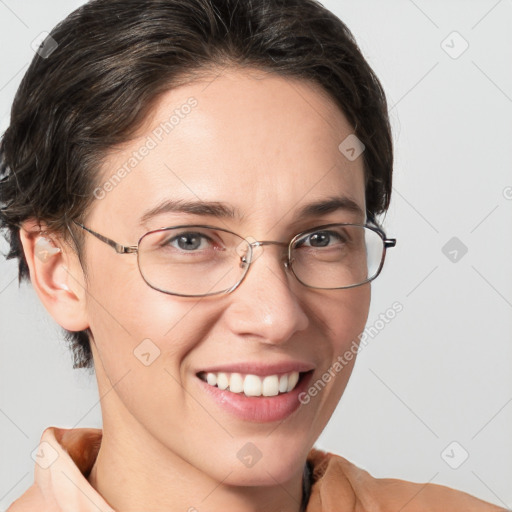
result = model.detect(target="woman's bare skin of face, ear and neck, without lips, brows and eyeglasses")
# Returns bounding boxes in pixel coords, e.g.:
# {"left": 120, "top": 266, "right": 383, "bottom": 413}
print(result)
{"left": 22, "top": 68, "right": 370, "bottom": 512}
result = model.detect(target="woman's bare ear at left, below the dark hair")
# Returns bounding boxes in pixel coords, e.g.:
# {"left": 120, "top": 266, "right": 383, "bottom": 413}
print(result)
{"left": 20, "top": 219, "right": 89, "bottom": 331}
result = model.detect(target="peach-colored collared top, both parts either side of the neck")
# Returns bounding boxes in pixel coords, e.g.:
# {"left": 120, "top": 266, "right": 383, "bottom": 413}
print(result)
{"left": 7, "top": 427, "right": 505, "bottom": 512}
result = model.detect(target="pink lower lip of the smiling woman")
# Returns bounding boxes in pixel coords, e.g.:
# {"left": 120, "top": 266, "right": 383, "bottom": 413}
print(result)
{"left": 196, "top": 371, "right": 313, "bottom": 423}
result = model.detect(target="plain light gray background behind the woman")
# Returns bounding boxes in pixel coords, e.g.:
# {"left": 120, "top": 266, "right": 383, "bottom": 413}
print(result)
{"left": 0, "top": 0, "right": 512, "bottom": 510}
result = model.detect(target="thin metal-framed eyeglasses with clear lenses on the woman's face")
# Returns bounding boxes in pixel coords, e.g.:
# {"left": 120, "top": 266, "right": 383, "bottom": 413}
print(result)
{"left": 73, "top": 221, "right": 396, "bottom": 297}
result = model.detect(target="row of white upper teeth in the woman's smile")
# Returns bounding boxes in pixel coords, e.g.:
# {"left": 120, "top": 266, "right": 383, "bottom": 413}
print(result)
{"left": 201, "top": 372, "right": 299, "bottom": 396}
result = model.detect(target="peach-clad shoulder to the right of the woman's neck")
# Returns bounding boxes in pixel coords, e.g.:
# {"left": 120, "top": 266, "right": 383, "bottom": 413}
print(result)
{"left": 307, "top": 449, "right": 505, "bottom": 512}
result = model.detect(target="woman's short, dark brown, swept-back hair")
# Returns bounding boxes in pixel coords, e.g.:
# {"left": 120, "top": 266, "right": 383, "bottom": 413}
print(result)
{"left": 0, "top": 0, "right": 393, "bottom": 368}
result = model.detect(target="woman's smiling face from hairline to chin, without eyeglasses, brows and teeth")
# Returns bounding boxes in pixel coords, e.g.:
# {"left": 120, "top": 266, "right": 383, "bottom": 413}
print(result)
{"left": 79, "top": 69, "right": 370, "bottom": 485}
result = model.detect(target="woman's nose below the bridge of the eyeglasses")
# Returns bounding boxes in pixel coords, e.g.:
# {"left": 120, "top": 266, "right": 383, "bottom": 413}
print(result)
{"left": 225, "top": 244, "right": 309, "bottom": 344}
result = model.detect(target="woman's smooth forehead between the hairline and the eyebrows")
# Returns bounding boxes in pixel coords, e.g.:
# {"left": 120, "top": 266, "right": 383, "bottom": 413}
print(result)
{"left": 91, "top": 69, "right": 365, "bottom": 236}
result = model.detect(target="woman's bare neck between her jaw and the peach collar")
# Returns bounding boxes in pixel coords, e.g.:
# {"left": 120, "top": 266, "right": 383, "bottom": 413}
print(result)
{"left": 88, "top": 400, "right": 304, "bottom": 512}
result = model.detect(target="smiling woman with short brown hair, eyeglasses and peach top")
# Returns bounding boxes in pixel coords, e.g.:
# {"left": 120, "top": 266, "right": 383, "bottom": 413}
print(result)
{"left": 1, "top": 0, "right": 499, "bottom": 512}
